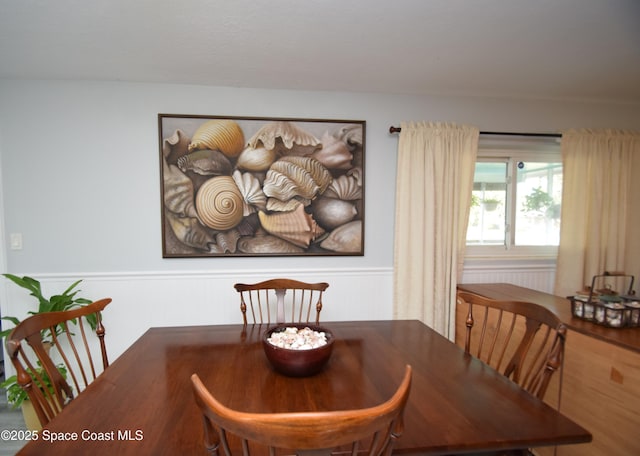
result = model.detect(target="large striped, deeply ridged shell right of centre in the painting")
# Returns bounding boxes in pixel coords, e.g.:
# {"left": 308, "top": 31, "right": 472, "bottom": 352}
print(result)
{"left": 262, "top": 157, "right": 333, "bottom": 205}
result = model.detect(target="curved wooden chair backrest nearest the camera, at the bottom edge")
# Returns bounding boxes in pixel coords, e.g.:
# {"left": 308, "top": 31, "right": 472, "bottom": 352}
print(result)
{"left": 191, "top": 365, "right": 411, "bottom": 456}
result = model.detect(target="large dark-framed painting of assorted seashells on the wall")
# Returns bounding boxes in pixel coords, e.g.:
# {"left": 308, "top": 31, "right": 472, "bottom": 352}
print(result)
{"left": 158, "top": 114, "right": 366, "bottom": 258}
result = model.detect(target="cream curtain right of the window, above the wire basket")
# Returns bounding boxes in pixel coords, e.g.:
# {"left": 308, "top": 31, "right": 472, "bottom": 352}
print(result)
{"left": 554, "top": 130, "right": 640, "bottom": 296}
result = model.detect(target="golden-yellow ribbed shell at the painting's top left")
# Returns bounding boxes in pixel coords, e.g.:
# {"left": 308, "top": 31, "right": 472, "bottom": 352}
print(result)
{"left": 189, "top": 119, "right": 244, "bottom": 157}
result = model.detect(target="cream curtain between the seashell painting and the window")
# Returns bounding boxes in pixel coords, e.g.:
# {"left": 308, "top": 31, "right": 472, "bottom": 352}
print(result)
{"left": 394, "top": 122, "right": 479, "bottom": 340}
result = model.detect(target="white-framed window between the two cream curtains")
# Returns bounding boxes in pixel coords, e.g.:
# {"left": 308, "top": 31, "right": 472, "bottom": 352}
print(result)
{"left": 467, "top": 137, "right": 562, "bottom": 256}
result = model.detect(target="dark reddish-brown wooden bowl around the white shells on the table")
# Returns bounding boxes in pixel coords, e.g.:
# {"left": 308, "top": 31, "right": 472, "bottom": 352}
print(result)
{"left": 262, "top": 323, "right": 334, "bottom": 377}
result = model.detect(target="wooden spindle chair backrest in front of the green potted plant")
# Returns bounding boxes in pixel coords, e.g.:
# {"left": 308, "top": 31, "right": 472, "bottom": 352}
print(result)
{"left": 6, "top": 298, "right": 111, "bottom": 426}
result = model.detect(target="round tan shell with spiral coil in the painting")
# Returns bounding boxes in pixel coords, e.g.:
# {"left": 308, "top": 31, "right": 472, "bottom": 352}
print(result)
{"left": 196, "top": 176, "right": 244, "bottom": 231}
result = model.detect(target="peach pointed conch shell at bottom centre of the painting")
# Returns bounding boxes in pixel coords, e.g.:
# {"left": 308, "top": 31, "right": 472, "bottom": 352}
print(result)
{"left": 258, "top": 204, "right": 324, "bottom": 248}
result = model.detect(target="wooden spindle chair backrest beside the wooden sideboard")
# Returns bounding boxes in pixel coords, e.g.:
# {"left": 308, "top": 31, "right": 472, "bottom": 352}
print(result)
{"left": 457, "top": 291, "right": 567, "bottom": 399}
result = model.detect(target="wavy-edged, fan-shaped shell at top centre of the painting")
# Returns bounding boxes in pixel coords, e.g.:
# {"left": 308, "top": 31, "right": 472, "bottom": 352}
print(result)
{"left": 249, "top": 121, "right": 322, "bottom": 155}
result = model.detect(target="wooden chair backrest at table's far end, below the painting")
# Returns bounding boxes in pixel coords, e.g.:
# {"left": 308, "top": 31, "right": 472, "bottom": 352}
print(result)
{"left": 234, "top": 279, "right": 329, "bottom": 325}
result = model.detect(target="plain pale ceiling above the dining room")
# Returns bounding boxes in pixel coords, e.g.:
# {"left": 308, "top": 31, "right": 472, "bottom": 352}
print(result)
{"left": 0, "top": 0, "right": 640, "bottom": 103}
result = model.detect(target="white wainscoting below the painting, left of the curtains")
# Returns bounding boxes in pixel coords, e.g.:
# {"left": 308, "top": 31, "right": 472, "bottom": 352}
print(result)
{"left": 2, "top": 268, "right": 393, "bottom": 375}
